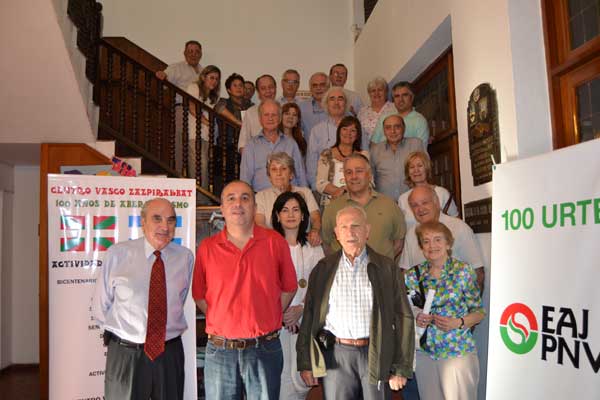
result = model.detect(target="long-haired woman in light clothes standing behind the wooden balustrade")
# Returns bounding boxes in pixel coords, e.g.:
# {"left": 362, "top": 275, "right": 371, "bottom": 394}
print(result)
{"left": 186, "top": 65, "right": 221, "bottom": 188}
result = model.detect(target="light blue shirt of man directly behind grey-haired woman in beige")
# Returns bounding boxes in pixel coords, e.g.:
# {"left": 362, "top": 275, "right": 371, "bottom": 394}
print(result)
{"left": 240, "top": 130, "right": 307, "bottom": 192}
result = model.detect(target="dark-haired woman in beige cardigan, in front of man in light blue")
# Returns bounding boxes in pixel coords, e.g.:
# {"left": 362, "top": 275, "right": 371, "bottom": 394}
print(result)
{"left": 316, "top": 115, "right": 369, "bottom": 207}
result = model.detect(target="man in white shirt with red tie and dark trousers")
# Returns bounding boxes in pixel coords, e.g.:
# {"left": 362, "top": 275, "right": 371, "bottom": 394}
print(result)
{"left": 92, "top": 198, "right": 194, "bottom": 400}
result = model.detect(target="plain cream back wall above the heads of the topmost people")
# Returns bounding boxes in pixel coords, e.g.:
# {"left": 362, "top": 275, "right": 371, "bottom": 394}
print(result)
{"left": 102, "top": 0, "right": 354, "bottom": 90}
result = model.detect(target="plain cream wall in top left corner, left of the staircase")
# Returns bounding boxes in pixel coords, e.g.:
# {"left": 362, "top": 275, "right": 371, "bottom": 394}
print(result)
{"left": 0, "top": 0, "right": 95, "bottom": 143}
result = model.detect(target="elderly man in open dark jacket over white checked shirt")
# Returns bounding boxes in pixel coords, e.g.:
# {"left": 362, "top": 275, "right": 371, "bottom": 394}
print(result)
{"left": 296, "top": 205, "right": 414, "bottom": 400}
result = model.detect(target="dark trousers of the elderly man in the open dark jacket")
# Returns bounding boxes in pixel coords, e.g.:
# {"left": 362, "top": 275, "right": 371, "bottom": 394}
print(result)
{"left": 323, "top": 343, "right": 392, "bottom": 400}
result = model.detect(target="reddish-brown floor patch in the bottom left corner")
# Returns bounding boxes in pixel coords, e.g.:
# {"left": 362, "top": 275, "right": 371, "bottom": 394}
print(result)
{"left": 0, "top": 366, "right": 40, "bottom": 400}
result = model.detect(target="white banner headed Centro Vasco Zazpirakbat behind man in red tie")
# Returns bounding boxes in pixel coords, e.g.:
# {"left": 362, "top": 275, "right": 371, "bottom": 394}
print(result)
{"left": 47, "top": 175, "right": 196, "bottom": 400}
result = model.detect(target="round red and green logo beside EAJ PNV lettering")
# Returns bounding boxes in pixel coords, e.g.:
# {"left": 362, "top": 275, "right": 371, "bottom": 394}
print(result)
{"left": 500, "top": 303, "right": 538, "bottom": 354}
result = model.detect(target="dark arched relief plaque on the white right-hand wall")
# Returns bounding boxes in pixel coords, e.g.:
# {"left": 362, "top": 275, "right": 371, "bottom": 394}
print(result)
{"left": 467, "top": 83, "right": 500, "bottom": 186}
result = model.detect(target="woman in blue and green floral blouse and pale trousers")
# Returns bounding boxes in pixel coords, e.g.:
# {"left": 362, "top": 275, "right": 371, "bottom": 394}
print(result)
{"left": 405, "top": 222, "right": 485, "bottom": 400}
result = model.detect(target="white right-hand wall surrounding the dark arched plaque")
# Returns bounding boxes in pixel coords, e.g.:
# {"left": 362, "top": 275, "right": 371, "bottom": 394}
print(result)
{"left": 354, "top": 0, "right": 552, "bottom": 397}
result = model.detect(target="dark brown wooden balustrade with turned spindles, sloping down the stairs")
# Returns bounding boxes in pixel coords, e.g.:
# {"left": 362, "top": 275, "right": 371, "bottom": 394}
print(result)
{"left": 94, "top": 38, "right": 240, "bottom": 203}
